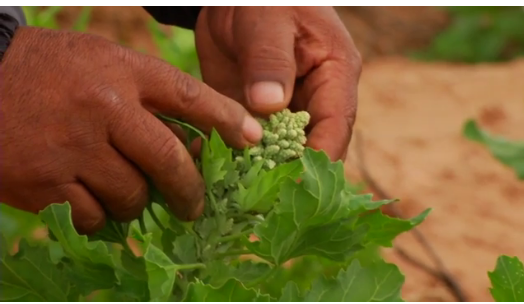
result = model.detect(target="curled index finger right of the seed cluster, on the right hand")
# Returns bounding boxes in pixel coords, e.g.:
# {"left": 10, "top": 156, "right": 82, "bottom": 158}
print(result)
{"left": 297, "top": 61, "right": 360, "bottom": 161}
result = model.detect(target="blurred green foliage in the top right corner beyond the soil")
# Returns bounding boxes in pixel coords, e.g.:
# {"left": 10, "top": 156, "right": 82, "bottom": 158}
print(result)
{"left": 412, "top": 6, "right": 524, "bottom": 63}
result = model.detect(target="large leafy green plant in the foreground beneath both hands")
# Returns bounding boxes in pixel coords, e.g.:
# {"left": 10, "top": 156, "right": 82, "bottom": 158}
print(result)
{"left": 0, "top": 111, "right": 429, "bottom": 301}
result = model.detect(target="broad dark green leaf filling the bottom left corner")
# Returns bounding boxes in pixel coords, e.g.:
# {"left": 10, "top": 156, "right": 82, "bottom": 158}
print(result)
{"left": 0, "top": 235, "right": 79, "bottom": 302}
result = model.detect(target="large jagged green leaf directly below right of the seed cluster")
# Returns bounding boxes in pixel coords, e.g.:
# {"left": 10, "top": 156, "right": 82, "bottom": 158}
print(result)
{"left": 246, "top": 148, "right": 425, "bottom": 264}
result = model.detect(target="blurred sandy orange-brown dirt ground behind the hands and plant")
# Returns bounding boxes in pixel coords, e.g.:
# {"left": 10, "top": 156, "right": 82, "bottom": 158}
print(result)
{"left": 50, "top": 7, "right": 524, "bottom": 301}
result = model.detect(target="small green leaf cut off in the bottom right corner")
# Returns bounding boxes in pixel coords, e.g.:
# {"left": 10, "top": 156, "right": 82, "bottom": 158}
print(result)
{"left": 488, "top": 255, "right": 524, "bottom": 302}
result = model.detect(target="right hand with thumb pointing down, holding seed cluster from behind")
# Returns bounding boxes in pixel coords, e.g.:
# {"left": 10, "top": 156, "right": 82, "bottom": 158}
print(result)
{"left": 195, "top": 7, "right": 361, "bottom": 160}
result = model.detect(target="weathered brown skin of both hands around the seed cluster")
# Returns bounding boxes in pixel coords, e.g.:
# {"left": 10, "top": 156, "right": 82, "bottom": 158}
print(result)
{"left": 0, "top": 7, "right": 361, "bottom": 234}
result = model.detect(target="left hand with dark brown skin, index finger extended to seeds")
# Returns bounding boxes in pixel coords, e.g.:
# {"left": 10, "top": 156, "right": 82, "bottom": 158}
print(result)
{"left": 0, "top": 27, "right": 261, "bottom": 233}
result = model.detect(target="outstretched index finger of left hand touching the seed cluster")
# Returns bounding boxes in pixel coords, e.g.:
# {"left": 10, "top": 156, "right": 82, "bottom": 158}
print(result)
{"left": 130, "top": 55, "right": 262, "bottom": 148}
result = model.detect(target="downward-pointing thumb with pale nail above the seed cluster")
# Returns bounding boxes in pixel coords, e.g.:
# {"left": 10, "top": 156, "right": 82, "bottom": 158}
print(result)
{"left": 234, "top": 7, "right": 296, "bottom": 114}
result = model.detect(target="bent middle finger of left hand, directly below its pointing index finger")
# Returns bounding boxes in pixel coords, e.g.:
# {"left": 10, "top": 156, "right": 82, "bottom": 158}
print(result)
{"left": 110, "top": 107, "right": 204, "bottom": 221}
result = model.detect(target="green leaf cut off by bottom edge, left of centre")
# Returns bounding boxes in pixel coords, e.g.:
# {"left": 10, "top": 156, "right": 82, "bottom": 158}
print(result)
{"left": 184, "top": 279, "right": 271, "bottom": 302}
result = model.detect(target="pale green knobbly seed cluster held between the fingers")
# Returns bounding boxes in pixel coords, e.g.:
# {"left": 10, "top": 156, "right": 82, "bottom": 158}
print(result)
{"left": 245, "top": 109, "right": 310, "bottom": 169}
